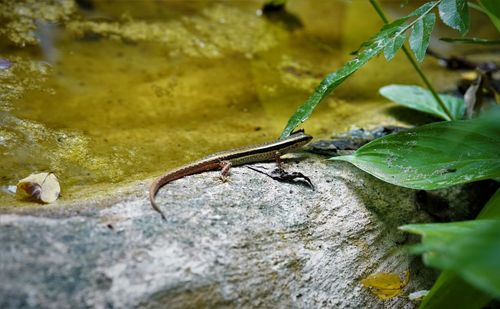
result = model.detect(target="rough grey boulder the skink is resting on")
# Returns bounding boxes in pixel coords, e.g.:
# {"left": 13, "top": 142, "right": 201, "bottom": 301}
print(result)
{"left": 0, "top": 158, "right": 433, "bottom": 308}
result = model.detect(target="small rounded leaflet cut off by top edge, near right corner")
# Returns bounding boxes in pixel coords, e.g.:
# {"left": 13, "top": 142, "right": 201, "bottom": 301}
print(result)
{"left": 438, "top": 0, "right": 469, "bottom": 34}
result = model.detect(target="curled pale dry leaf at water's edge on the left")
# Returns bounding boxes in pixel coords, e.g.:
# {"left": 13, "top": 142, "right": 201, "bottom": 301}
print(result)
{"left": 16, "top": 173, "right": 61, "bottom": 203}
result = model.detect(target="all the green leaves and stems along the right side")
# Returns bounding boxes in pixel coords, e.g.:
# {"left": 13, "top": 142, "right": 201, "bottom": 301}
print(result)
{"left": 281, "top": 0, "right": 500, "bottom": 308}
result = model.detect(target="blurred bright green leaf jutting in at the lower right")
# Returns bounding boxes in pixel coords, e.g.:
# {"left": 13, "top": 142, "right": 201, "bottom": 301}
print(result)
{"left": 400, "top": 220, "right": 500, "bottom": 297}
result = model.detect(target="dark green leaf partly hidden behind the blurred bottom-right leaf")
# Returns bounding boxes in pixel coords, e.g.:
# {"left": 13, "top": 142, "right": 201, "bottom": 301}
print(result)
{"left": 420, "top": 189, "right": 500, "bottom": 309}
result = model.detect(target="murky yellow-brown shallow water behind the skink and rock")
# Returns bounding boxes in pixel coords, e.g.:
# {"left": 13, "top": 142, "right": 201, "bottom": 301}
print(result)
{"left": 0, "top": 0, "right": 474, "bottom": 205}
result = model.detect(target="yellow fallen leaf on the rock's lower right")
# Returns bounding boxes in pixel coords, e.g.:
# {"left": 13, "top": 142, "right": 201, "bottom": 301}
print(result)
{"left": 361, "top": 272, "right": 410, "bottom": 300}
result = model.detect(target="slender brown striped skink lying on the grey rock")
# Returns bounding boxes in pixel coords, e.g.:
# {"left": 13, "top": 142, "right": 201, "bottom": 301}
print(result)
{"left": 149, "top": 130, "right": 312, "bottom": 220}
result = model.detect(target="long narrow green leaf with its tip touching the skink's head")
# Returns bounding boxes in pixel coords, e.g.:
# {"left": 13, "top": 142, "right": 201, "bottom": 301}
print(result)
{"left": 280, "top": 1, "right": 438, "bottom": 139}
